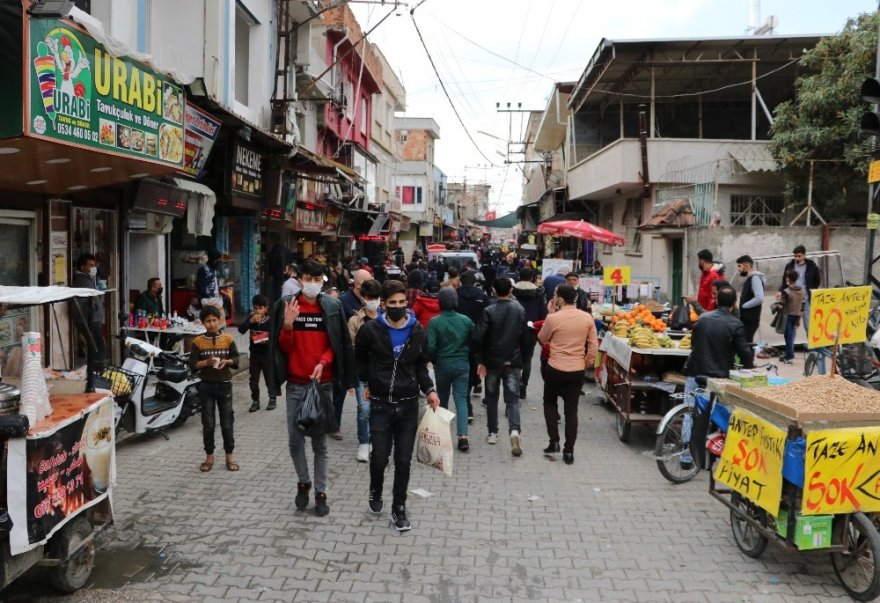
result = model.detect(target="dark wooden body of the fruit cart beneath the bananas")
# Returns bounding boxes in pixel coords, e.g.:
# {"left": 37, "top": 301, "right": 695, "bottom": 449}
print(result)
{"left": 598, "top": 333, "right": 690, "bottom": 442}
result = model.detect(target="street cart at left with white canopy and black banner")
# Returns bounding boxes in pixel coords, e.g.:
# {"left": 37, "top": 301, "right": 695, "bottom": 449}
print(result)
{"left": 0, "top": 286, "right": 116, "bottom": 592}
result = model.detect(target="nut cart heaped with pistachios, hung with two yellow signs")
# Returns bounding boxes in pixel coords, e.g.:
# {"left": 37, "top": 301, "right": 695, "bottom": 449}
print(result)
{"left": 707, "top": 376, "right": 880, "bottom": 601}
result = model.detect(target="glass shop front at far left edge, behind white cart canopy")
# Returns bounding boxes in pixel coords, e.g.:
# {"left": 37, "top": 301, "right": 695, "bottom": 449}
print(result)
{"left": 0, "top": 211, "right": 37, "bottom": 377}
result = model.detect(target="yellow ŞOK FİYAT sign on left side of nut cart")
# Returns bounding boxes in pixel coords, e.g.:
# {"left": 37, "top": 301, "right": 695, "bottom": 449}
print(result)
{"left": 715, "top": 409, "right": 786, "bottom": 517}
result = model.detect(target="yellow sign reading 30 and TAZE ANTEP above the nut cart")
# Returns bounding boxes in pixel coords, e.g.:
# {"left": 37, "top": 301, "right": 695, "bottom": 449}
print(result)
{"left": 807, "top": 285, "right": 871, "bottom": 348}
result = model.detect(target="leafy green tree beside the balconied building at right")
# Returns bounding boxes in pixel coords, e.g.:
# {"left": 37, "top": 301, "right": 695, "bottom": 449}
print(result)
{"left": 770, "top": 12, "right": 880, "bottom": 220}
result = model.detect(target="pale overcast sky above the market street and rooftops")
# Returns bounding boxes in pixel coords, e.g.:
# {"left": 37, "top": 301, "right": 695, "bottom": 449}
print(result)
{"left": 351, "top": 0, "right": 877, "bottom": 215}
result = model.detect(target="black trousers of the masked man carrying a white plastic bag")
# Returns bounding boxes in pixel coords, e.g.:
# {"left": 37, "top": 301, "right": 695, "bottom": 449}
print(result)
{"left": 370, "top": 398, "right": 419, "bottom": 506}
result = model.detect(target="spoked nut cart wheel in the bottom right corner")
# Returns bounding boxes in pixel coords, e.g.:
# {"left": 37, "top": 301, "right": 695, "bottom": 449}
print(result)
{"left": 831, "top": 513, "right": 880, "bottom": 601}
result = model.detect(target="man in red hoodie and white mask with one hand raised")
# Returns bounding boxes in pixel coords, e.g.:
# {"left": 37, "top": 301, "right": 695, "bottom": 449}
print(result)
{"left": 270, "top": 260, "right": 355, "bottom": 516}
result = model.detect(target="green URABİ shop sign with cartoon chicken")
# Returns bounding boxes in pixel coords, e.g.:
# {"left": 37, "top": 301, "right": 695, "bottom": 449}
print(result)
{"left": 28, "top": 19, "right": 185, "bottom": 167}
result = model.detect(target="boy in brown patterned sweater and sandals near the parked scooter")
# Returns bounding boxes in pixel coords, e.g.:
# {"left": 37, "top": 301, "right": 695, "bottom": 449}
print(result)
{"left": 189, "top": 305, "right": 239, "bottom": 473}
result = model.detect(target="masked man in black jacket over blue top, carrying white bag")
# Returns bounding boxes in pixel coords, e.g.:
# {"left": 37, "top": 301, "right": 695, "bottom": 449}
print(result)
{"left": 355, "top": 280, "right": 440, "bottom": 532}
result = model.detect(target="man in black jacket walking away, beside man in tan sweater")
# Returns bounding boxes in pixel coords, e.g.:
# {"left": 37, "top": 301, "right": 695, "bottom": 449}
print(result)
{"left": 474, "top": 277, "right": 530, "bottom": 456}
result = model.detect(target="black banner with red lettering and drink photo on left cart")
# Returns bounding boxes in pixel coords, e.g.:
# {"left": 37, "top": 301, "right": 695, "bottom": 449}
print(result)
{"left": 6, "top": 394, "right": 115, "bottom": 555}
